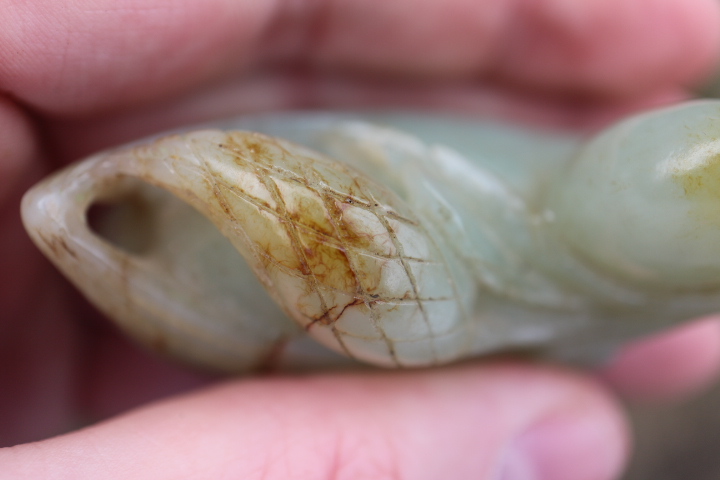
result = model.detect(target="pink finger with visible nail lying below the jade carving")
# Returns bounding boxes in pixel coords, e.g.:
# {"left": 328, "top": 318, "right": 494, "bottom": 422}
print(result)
{"left": 0, "top": 365, "right": 627, "bottom": 480}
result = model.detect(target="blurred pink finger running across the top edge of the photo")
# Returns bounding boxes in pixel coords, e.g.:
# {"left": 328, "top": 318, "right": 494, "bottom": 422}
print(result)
{"left": 0, "top": 0, "right": 720, "bottom": 114}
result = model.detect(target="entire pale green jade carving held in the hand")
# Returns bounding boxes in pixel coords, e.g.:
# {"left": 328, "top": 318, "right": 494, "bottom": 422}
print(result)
{"left": 22, "top": 101, "right": 720, "bottom": 372}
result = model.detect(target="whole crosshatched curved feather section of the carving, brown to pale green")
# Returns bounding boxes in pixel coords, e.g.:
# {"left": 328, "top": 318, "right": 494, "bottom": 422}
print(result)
{"left": 149, "top": 132, "right": 476, "bottom": 367}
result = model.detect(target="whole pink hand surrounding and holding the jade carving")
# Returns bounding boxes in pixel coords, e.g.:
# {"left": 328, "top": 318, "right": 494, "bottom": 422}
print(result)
{"left": 0, "top": 0, "right": 720, "bottom": 480}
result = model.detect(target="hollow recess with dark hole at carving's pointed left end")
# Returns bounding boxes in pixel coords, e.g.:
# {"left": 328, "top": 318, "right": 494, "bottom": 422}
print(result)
{"left": 86, "top": 177, "right": 292, "bottom": 334}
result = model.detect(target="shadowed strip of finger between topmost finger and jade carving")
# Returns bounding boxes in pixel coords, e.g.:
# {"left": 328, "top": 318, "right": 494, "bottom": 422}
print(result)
{"left": 44, "top": 75, "right": 687, "bottom": 165}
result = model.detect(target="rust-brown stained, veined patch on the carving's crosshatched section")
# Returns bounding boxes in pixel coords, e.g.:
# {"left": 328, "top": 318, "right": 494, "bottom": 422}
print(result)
{"left": 208, "top": 132, "right": 424, "bottom": 334}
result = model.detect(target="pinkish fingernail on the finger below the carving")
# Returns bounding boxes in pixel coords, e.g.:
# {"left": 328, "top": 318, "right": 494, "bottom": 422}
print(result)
{"left": 497, "top": 414, "right": 625, "bottom": 480}
